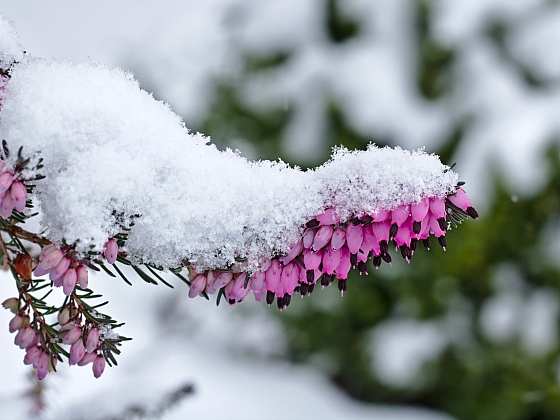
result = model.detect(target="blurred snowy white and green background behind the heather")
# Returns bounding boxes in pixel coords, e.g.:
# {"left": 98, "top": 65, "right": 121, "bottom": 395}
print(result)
{"left": 0, "top": 0, "right": 560, "bottom": 420}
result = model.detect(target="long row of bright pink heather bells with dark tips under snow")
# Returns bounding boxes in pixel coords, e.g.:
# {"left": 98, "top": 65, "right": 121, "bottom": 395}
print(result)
{"left": 189, "top": 187, "right": 478, "bottom": 310}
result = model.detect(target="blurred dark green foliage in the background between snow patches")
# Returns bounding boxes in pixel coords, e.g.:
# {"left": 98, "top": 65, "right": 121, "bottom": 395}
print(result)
{"left": 191, "top": 0, "right": 560, "bottom": 420}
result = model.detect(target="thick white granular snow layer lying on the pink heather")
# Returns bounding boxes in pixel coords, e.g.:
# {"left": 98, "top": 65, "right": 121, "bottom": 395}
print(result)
{"left": 0, "top": 13, "right": 457, "bottom": 269}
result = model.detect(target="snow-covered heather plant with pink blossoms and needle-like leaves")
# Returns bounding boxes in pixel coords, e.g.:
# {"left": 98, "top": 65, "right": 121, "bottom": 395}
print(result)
{"left": 0, "top": 13, "right": 478, "bottom": 380}
